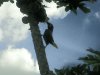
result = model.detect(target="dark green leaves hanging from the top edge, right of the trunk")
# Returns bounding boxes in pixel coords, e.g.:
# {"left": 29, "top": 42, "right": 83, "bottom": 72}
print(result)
{"left": 53, "top": 0, "right": 96, "bottom": 14}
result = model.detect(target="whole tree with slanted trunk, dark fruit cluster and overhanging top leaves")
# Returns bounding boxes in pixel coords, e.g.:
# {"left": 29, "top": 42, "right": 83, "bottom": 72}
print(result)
{"left": 0, "top": 0, "right": 95, "bottom": 75}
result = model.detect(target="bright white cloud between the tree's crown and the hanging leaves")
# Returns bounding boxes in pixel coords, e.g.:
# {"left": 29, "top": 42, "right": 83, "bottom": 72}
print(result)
{"left": 43, "top": 1, "right": 70, "bottom": 19}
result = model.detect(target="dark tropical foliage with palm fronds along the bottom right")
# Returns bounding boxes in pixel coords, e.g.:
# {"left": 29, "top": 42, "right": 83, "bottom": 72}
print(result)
{"left": 55, "top": 48, "right": 100, "bottom": 75}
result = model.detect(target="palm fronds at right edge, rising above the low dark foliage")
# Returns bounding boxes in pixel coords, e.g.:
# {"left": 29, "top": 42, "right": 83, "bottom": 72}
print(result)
{"left": 79, "top": 48, "right": 100, "bottom": 70}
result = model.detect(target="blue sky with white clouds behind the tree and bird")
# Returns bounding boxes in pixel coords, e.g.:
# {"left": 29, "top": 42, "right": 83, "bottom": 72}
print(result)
{"left": 0, "top": 0, "right": 100, "bottom": 75}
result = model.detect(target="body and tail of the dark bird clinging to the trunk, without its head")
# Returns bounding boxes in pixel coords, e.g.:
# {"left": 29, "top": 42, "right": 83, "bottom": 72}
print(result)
{"left": 43, "top": 29, "right": 58, "bottom": 48}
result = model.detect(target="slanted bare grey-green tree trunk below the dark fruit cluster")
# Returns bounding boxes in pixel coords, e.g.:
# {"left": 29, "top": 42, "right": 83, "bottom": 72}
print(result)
{"left": 30, "top": 23, "right": 54, "bottom": 75}
